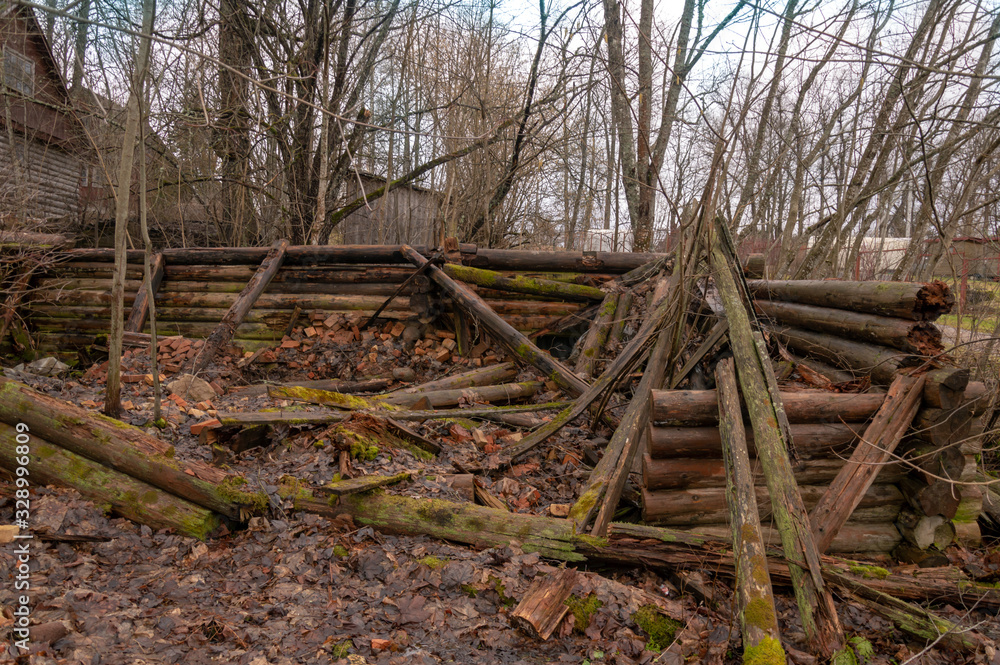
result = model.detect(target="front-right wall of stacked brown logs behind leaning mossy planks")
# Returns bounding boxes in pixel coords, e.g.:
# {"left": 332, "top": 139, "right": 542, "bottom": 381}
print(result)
{"left": 643, "top": 390, "right": 905, "bottom": 553}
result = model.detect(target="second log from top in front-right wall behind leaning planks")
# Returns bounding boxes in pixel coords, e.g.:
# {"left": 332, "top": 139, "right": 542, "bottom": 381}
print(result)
{"left": 647, "top": 423, "right": 865, "bottom": 459}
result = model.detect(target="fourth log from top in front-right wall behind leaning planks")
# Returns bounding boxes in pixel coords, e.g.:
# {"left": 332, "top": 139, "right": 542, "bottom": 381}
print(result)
{"left": 642, "top": 484, "right": 906, "bottom": 526}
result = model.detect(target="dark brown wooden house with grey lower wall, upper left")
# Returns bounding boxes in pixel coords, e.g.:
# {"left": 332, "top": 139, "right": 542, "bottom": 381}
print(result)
{"left": 0, "top": 0, "right": 88, "bottom": 224}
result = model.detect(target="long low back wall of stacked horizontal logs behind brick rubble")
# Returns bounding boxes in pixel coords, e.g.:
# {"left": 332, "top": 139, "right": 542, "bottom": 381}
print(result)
{"left": 27, "top": 245, "right": 654, "bottom": 352}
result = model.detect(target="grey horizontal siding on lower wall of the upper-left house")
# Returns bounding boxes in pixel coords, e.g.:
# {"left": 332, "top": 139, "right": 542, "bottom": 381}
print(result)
{"left": 0, "top": 131, "right": 81, "bottom": 218}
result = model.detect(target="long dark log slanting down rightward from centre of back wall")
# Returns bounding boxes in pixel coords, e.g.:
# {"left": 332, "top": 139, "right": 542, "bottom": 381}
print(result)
{"left": 401, "top": 245, "right": 589, "bottom": 395}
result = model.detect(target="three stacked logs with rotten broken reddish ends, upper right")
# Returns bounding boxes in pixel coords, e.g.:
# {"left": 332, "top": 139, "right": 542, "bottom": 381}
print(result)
{"left": 748, "top": 280, "right": 955, "bottom": 386}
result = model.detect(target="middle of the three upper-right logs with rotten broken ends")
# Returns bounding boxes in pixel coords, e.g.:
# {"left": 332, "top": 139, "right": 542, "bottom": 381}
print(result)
{"left": 754, "top": 300, "right": 944, "bottom": 356}
